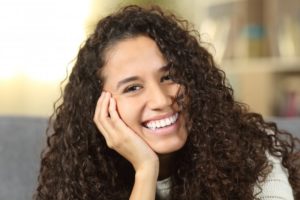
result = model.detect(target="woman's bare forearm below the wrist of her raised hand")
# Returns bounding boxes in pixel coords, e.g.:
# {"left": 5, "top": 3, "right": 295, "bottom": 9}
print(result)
{"left": 130, "top": 162, "right": 158, "bottom": 200}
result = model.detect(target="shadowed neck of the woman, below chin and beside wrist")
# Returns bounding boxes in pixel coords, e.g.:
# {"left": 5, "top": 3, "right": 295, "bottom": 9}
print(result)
{"left": 158, "top": 153, "right": 175, "bottom": 180}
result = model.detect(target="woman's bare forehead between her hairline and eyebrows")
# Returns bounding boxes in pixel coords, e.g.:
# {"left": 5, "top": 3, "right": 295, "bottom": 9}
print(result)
{"left": 102, "top": 36, "right": 166, "bottom": 79}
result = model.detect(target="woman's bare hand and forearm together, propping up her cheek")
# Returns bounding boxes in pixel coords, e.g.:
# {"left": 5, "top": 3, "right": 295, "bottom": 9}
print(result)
{"left": 94, "top": 92, "right": 159, "bottom": 200}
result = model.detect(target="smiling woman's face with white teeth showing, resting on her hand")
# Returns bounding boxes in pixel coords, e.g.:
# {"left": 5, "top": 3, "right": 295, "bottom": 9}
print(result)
{"left": 102, "top": 36, "right": 187, "bottom": 154}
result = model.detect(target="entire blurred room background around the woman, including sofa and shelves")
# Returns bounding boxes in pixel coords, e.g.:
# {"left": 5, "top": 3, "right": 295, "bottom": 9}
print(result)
{"left": 0, "top": 0, "right": 300, "bottom": 200}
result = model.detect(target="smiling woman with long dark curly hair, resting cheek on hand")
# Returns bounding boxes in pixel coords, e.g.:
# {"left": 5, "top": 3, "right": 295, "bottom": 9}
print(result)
{"left": 35, "top": 6, "right": 300, "bottom": 200}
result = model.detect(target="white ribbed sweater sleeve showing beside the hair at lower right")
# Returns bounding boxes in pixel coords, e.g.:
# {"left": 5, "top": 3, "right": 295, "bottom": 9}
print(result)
{"left": 254, "top": 153, "right": 294, "bottom": 200}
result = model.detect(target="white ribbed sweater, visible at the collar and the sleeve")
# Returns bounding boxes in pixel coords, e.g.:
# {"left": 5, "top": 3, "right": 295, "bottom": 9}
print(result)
{"left": 156, "top": 154, "right": 294, "bottom": 200}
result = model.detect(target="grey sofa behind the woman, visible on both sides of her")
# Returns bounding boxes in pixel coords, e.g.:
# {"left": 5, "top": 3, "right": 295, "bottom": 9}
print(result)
{"left": 0, "top": 116, "right": 300, "bottom": 200}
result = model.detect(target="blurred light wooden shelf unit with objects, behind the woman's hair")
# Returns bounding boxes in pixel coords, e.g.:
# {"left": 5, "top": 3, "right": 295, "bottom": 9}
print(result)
{"left": 201, "top": 0, "right": 300, "bottom": 116}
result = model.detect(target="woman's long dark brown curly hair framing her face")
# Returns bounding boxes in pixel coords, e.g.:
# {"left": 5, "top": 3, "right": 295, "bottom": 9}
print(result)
{"left": 34, "top": 6, "right": 300, "bottom": 200}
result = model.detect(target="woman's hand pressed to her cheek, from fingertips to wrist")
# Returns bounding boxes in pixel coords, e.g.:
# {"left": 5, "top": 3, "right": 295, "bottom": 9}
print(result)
{"left": 94, "top": 92, "right": 159, "bottom": 173}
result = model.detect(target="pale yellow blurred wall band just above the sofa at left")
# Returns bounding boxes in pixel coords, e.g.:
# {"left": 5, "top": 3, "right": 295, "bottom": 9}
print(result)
{"left": 0, "top": 77, "right": 60, "bottom": 116}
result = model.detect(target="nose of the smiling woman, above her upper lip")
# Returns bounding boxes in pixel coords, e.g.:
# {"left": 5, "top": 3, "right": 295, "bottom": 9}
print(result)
{"left": 147, "top": 86, "right": 175, "bottom": 110}
